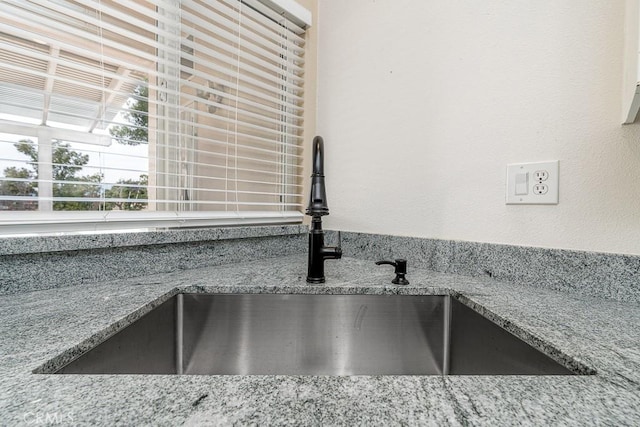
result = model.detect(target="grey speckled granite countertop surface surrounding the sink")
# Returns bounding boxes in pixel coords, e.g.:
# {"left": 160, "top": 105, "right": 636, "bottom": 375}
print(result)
{"left": 0, "top": 256, "right": 640, "bottom": 425}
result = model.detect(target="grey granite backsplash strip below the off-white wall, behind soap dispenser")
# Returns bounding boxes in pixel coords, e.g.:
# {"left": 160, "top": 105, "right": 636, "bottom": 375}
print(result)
{"left": 336, "top": 232, "right": 640, "bottom": 303}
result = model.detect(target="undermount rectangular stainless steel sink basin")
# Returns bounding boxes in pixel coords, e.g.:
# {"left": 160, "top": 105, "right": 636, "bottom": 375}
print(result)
{"left": 57, "top": 294, "right": 572, "bottom": 375}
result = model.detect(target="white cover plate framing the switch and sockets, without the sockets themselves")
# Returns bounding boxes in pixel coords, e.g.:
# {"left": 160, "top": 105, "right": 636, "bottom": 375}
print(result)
{"left": 506, "top": 160, "right": 560, "bottom": 205}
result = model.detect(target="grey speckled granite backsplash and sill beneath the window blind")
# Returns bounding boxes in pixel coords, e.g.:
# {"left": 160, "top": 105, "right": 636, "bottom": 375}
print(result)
{"left": 0, "top": 224, "right": 307, "bottom": 295}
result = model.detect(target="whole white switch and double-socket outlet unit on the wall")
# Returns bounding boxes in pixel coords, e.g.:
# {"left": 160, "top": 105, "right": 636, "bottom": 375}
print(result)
{"left": 506, "top": 160, "right": 560, "bottom": 205}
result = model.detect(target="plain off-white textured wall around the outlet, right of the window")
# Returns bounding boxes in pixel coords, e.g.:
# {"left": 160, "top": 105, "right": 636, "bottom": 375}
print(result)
{"left": 317, "top": 0, "right": 640, "bottom": 254}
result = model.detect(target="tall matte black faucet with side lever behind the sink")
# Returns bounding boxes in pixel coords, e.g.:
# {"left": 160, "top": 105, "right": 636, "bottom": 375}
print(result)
{"left": 306, "top": 136, "right": 342, "bottom": 283}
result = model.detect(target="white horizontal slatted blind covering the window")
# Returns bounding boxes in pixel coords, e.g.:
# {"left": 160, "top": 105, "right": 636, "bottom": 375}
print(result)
{"left": 0, "top": 0, "right": 305, "bottom": 233}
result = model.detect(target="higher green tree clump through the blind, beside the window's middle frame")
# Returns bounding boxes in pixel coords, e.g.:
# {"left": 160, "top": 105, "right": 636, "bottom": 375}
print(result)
{"left": 109, "top": 85, "right": 149, "bottom": 145}
